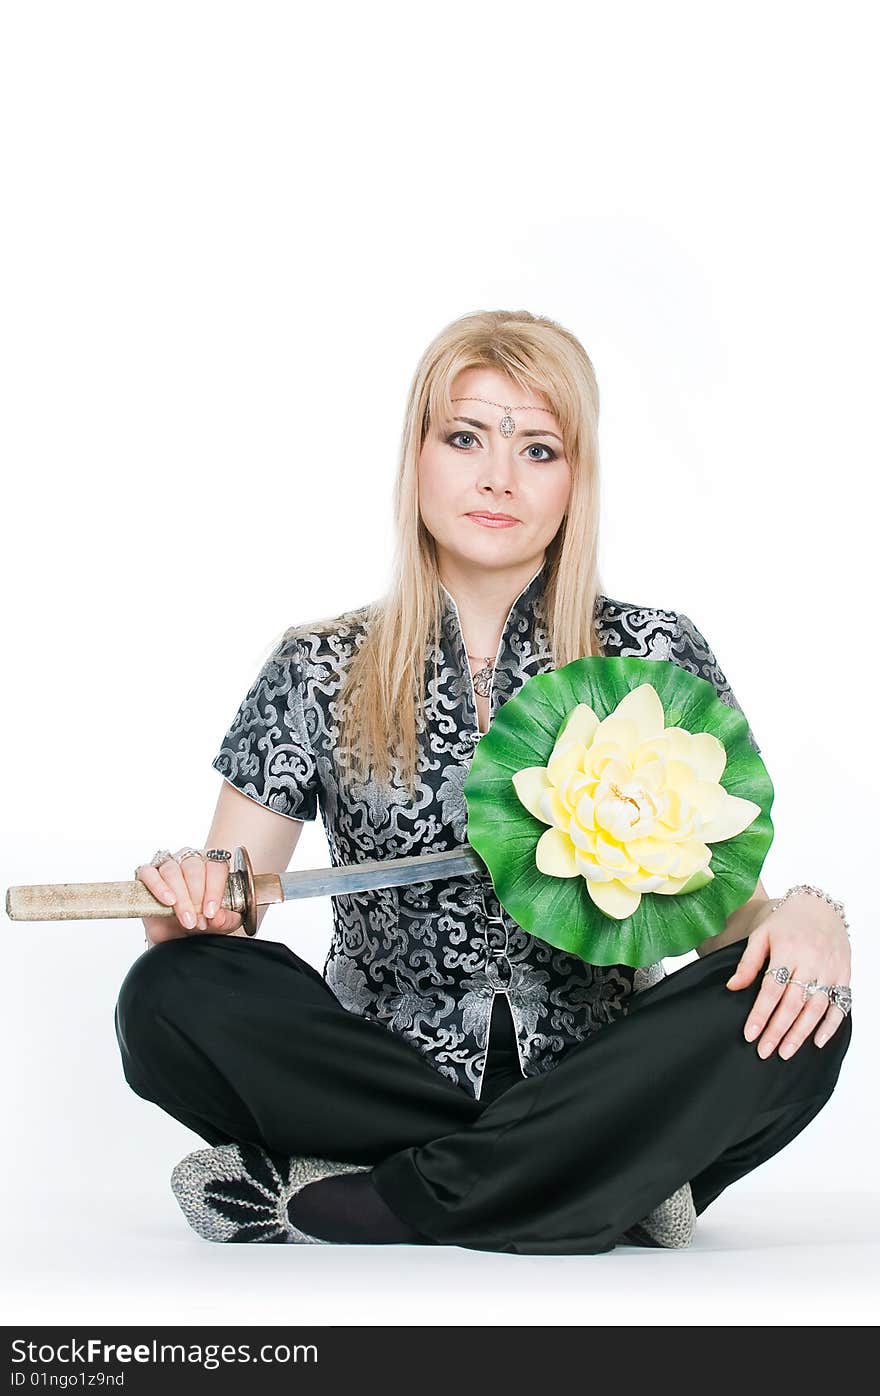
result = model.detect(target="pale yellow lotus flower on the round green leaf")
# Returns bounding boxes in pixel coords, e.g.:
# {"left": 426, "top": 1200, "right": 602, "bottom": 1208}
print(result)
{"left": 513, "top": 684, "right": 761, "bottom": 920}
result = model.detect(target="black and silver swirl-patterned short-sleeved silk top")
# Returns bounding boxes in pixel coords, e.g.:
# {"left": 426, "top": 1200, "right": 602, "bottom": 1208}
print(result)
{"left": 212, "top": 561, "right": 760, "bottom": 1099}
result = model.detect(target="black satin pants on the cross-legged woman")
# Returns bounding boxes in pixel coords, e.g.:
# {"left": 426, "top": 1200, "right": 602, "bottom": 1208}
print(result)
{"left": 115, "top": 933, "right": 852, "bottom": 1255}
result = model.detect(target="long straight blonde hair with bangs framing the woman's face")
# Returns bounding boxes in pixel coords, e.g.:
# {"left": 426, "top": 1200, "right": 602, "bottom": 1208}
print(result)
{"left": 291, "top": 310, "right": 601, "bottom": 799}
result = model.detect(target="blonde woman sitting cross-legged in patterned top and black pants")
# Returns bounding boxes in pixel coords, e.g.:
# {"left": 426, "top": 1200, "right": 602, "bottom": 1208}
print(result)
{"left": 116, "top": 305, "right": 852, "bottom": 1255}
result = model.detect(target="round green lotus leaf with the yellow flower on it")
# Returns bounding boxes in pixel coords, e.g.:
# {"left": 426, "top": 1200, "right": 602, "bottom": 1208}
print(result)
{"left": 464, "top": 656, "right": 774, "bottom": 966}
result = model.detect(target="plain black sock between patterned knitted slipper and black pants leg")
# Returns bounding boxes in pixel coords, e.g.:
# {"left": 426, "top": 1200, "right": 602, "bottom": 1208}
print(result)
{"left": 288, "top": 1171, "right": 434, "bottom": 1245}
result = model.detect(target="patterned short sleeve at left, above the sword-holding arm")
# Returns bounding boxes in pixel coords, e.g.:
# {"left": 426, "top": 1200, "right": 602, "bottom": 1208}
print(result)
{"left": 212, "top": 632, "right": 318, "bottom": 819}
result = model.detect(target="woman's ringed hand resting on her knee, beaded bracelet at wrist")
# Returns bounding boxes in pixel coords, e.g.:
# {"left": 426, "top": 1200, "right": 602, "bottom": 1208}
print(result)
{"left": 726, "top": 892, "right": 851, "bottom": 1057}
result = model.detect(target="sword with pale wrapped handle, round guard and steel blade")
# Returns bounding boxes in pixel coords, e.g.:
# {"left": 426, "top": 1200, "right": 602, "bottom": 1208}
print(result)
{"left": 6, "top": 843, "right": 487, "bottom": 935}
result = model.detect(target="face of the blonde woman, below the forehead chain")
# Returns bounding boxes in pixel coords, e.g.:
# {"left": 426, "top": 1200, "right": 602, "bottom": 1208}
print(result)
{"left": 419, "top": 369, "right": 571, "bottom": 572}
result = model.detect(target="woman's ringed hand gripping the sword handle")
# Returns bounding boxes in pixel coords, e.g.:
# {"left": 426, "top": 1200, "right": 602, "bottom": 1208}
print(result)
{"left": 135, "top": 849, "right": 242, "bottom": 945}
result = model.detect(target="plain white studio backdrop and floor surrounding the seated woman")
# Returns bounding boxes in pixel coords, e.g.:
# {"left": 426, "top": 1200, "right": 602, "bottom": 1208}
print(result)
{"left": 0, "top": 0, "right": 880, "bottom": 1323}
